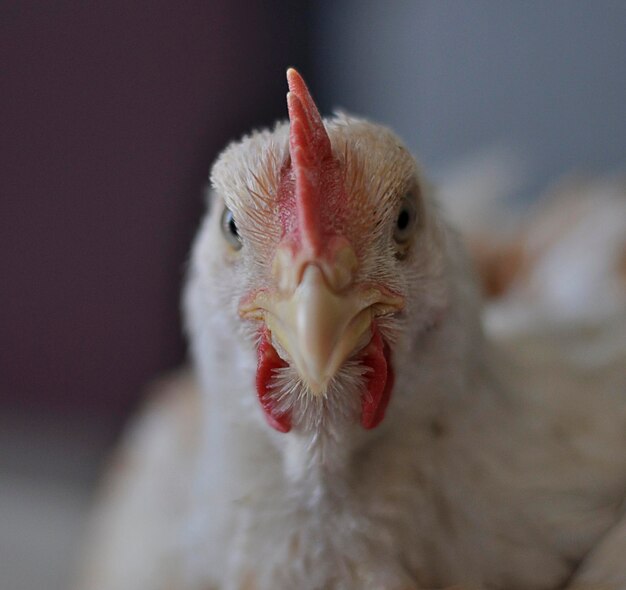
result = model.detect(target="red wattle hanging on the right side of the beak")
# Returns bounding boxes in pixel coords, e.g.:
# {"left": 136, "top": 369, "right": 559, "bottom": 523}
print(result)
{"left": 361, "top": 326, "right": 394, "bottom": 430}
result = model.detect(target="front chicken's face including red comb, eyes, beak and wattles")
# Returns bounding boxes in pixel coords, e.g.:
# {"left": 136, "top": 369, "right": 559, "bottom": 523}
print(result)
{"left": 190, "top": 70, "right": 444, "bottom": 440}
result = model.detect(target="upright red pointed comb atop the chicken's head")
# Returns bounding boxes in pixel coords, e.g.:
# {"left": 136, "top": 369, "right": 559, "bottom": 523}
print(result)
{"left": 287, "top": 68, "right": 333, "bottom": 252}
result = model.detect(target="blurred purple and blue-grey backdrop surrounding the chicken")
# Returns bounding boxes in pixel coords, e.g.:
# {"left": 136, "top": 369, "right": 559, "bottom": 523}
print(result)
{"left": 0, "top": 0, "right": 626, "bottom": 590}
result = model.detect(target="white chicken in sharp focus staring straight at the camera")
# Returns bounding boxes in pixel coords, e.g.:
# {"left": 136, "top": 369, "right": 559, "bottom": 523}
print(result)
{"left": 81, "top": 69, "right": 626, "bottom": 590}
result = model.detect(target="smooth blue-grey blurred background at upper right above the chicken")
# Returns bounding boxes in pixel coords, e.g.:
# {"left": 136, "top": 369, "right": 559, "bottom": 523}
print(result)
{"left": 314, "top": 0, "right": 626, "bottom": 191}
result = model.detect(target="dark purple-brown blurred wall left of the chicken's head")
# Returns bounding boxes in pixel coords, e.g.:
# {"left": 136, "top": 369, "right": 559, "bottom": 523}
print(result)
{"left": 0, "top": 0, "right": 308, "bottom": 426}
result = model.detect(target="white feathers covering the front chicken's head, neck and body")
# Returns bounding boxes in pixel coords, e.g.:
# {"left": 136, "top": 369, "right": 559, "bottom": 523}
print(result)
{"left": 77, "top": 115, "right": 626, "bottom": 590}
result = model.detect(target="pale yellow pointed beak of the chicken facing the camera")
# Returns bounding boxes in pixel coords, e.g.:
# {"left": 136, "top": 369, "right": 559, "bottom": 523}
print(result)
{"left": 236, "top": 246, "right": 402, "bottom": 395}
